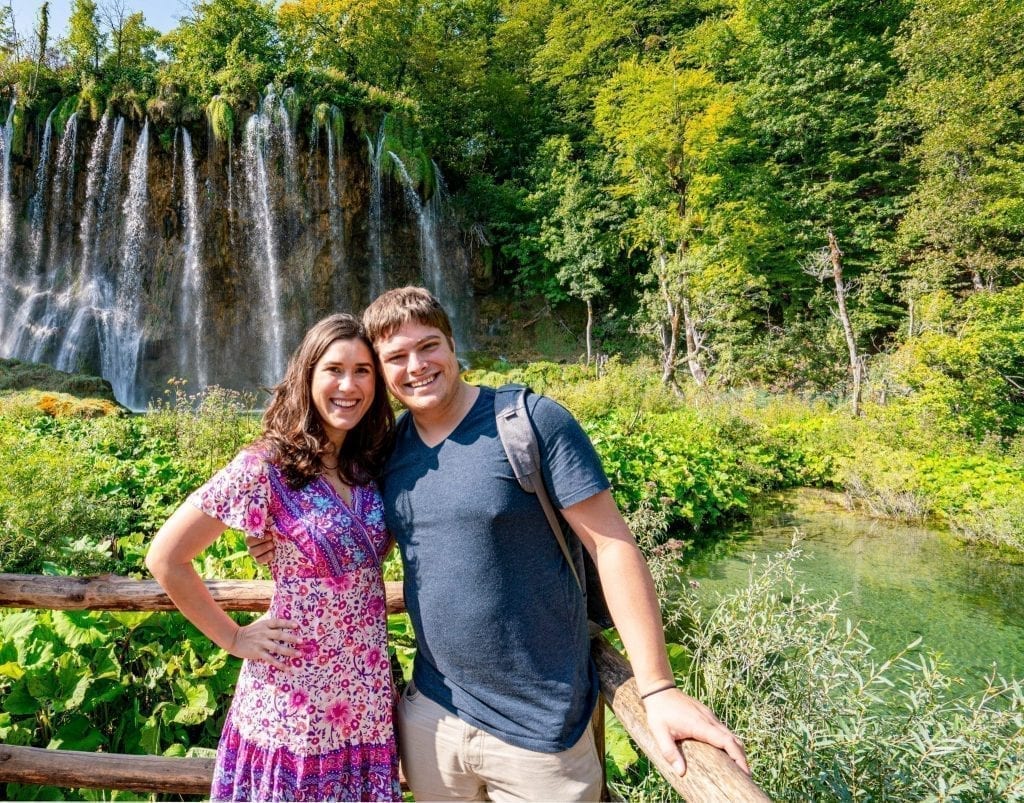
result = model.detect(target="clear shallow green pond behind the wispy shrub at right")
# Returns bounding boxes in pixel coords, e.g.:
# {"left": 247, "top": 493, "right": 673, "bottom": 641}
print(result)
{"left": 687, "top": 494, "right": 1024, "bottom": 688}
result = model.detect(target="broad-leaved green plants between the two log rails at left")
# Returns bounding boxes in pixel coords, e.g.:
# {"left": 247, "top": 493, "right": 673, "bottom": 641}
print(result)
{"left": 0, "top": 610, "right": 240, "bottom": 778}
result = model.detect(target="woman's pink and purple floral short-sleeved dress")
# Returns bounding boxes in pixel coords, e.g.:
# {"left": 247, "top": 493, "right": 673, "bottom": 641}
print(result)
{"left": 188, "top": 451, "right": 401, "bottom": 800}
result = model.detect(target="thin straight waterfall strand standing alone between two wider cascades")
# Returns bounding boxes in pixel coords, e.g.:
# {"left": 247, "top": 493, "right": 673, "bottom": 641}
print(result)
{"left": 179, "top": 128, "right": 209, "bottom": 389}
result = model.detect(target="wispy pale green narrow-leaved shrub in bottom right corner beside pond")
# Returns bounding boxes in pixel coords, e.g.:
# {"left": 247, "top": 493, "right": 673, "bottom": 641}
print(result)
{"left": 673, "top": 551, "right": 1024, "bottom": 801}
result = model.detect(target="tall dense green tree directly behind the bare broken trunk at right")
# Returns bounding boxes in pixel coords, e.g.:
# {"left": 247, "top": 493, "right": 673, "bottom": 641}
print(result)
{"left": 730, "top": 0, "right": 911, "bottom": 333}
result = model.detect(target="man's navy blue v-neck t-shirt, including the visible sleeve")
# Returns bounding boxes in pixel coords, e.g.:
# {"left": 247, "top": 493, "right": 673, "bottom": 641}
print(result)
{"left": 382, "top": 387, "right": 608, "bottom": 753}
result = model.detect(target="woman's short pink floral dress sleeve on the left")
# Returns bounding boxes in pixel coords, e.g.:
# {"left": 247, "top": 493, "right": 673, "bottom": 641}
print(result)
{"left": 188, "top": 451, "right": 270, "bottom": 538}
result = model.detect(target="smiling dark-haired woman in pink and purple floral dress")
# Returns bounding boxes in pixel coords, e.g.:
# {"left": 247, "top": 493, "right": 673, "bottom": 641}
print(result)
{"left": 145, "top": 314, "right": 400, "bottom": 800}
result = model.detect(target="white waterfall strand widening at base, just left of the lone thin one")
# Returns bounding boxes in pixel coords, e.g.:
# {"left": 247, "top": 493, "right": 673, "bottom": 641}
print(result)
{"left": 99, "top": 120, "right": 150, "bottom": 407}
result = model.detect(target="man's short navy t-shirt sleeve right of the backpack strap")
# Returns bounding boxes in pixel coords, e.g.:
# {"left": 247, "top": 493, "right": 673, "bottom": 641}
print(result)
{"left": 527, "top": 396, "right": 610, "bottom": 510}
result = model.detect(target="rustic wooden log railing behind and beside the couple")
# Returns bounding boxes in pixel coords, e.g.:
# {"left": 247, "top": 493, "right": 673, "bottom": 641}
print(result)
{"left": 0, "top": 574, "right": 769, "bottom": 803}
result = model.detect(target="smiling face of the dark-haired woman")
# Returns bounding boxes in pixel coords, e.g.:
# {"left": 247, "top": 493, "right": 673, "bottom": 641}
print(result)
{"left": 310, "top": 339, "right": 376, "bottom": 448}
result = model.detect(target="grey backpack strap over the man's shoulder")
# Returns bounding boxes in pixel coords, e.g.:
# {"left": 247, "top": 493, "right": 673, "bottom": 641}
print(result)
{"left": 495, "top": 384, "right": 587, "bottom": 595}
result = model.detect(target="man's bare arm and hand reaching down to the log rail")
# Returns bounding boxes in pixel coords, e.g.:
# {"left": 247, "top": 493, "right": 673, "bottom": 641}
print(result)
{"left": 562, "top": 491, "right": 751, "bottom": 775}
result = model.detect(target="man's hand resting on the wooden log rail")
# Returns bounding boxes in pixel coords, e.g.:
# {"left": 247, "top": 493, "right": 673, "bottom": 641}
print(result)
{"left": 643, "top": 688, "right": 751, "bottom": 775}
